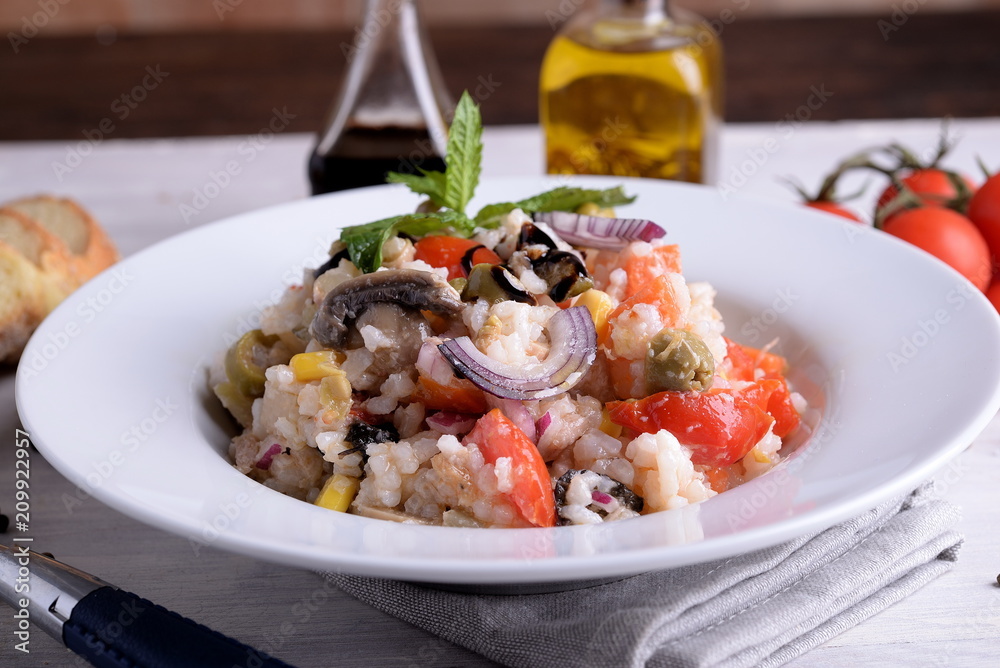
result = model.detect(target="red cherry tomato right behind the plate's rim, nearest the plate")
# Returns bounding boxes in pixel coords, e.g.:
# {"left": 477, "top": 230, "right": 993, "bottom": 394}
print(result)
{"left": 883, "top": 207, "right": 992, "bottom": 290}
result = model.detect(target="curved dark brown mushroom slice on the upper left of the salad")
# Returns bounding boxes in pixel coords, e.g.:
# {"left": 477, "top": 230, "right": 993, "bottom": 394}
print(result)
{"left": 309, "top": 269, "right": 463, "bottom": 348}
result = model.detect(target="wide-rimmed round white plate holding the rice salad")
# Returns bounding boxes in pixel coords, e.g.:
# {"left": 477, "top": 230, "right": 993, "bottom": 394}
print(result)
{"left": 17, "top": 178, "right": 1000, "bottom": 584}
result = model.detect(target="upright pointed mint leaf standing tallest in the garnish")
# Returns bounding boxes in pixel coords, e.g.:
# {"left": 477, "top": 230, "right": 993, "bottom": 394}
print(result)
{"left": 442, "top": 91, "right": 483, "bottom": 211}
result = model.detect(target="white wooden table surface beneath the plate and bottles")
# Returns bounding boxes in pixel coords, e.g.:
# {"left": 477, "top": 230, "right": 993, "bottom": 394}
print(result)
{"left": 0, "top": 119, "right": 1000, "bottom": 668}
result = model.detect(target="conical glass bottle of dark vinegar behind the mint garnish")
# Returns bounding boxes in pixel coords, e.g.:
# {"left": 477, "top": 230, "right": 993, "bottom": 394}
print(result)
{"left": 309, "top": 0, "right": 452, "bottom": 195}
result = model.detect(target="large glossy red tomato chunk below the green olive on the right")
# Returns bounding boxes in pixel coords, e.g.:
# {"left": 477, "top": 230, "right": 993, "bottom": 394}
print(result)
{"left": 608, "top": 388, "right": 774, "bottom": 467}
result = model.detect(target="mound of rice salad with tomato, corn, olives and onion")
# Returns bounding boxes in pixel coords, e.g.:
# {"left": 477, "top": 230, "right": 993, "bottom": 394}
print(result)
{"left": 210, "top": 204, "right": 806, "bottom": 527}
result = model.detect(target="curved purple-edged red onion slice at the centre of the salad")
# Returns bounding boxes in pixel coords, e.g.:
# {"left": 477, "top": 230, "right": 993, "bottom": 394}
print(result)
{"left": 438, "top": 306, "right": 597, "bottom": 401}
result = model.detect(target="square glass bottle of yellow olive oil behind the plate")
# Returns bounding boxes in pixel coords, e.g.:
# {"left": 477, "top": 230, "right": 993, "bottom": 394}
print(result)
{"left": 540, "top": 0, "right": 722, "bottom": 183}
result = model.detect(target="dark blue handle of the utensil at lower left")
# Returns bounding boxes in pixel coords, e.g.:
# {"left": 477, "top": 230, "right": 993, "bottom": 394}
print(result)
{"left": 63, "top": 587, "right": 292, "bottom": 668}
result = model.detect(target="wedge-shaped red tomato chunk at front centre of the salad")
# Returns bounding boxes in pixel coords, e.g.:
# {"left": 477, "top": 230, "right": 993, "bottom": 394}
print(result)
{"left": 462, "top": 408, "right": 556, "bottom": 527}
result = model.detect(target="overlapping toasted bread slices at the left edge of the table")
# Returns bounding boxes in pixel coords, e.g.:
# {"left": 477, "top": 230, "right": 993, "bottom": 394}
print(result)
{"left": 0, "top": 196, "right": 118, "bottom": 362}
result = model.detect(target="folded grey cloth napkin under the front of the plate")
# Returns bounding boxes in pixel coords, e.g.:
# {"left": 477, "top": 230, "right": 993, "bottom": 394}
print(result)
{"left": 328, "top": 485, "right": 962, "bottom": 668}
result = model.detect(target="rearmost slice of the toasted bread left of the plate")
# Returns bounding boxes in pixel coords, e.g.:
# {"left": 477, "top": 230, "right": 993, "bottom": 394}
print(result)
{"left": 4, "top": 195, "right": 118, "bottom": 285}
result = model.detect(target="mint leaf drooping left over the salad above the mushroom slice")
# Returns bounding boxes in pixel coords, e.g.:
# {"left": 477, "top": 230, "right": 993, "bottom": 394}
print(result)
{"left": 340, "top": 211, "right": 475, "bottom": 274}
